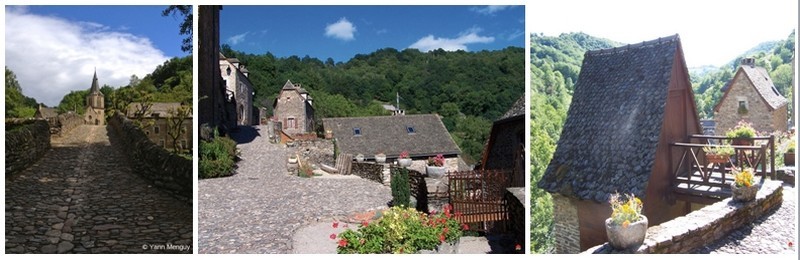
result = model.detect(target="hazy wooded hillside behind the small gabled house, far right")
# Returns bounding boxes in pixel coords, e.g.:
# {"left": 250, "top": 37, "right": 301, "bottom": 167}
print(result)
{"left": 690, "top": 32, "right": 795, "bottom": 118}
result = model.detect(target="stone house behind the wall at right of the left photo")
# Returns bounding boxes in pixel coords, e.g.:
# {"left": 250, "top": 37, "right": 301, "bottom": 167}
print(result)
{"left": 125, "top": 102, "right": 193, "bottom": 150}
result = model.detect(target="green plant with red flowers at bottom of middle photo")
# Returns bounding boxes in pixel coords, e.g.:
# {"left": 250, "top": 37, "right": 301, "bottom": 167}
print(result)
{"left": 336, "top": 205, "right": 462, "bottom": 254}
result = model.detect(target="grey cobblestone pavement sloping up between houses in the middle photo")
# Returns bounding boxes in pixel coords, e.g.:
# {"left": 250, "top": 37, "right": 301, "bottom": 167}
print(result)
{"left": 197, "top": 126, "right": 391, "bottom": 254}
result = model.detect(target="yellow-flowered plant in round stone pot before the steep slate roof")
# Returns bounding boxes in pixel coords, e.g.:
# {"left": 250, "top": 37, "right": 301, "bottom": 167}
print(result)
{"left": 606, "top": 193, "right": 647, "bottom": 250}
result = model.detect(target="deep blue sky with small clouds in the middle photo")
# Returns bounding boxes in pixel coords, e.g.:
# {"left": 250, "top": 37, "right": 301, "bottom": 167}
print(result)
{"left": 220, "top": 6, "right": 525, "bottom": 62}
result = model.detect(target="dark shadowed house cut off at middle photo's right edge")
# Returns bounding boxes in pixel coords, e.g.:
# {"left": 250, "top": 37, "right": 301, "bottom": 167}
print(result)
{"left": 481, "top": 96, "right": 528, "bottom": 187}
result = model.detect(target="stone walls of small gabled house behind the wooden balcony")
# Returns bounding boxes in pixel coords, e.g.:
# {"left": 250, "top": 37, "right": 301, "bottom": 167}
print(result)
{"left": 714, "top": 69, "right": 787, "bottom": 135}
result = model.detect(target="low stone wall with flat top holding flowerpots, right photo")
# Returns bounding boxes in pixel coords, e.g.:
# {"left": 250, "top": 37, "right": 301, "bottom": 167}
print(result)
{"left": 584, "top": 181, "right": 783, "bottom": 254}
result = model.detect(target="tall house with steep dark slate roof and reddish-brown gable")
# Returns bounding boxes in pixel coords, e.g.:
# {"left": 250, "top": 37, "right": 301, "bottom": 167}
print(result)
{"left": 537, "top": 35, "right": 702, "bottom": 253}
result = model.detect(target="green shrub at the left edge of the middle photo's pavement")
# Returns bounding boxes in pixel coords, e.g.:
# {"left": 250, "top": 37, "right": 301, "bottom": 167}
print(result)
{"left": 198, "top": 136, "right": 237, "bottom": 179}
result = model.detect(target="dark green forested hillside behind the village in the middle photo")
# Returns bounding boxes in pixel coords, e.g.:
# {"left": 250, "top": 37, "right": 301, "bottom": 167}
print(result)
{"left": 221, "top": 45, "right": 525, "bottom": 162}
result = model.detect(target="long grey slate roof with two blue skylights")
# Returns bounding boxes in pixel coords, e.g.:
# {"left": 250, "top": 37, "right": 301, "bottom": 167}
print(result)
{"left": 322, "top": 114, "right": 461, "bottom": 159}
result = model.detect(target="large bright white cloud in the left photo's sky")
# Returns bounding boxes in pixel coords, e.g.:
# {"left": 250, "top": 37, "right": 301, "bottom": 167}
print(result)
{"left": 5, "top": 8, "right": 169, "bottom": 106}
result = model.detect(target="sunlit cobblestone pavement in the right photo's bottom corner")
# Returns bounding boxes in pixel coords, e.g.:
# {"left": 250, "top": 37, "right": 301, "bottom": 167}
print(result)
{"left": 694, "top": 185, "right": 797, "bottom": 254}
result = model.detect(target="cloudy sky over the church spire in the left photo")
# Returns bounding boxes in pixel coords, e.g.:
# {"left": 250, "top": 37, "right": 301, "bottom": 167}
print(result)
{"left": 5, "top": 6, "right": 190, "bottom": 106}
